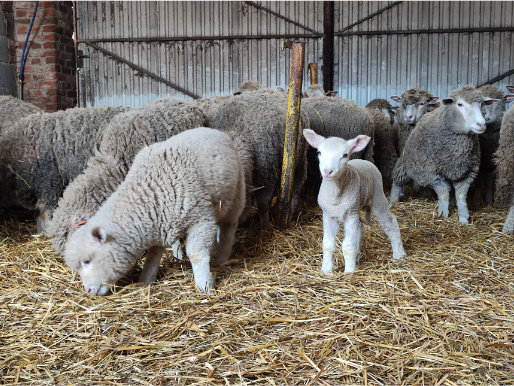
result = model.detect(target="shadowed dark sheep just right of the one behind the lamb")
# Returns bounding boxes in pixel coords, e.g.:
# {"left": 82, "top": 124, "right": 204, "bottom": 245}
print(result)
{"left": 366, "top": 107, "right": 398, "bottom": 189}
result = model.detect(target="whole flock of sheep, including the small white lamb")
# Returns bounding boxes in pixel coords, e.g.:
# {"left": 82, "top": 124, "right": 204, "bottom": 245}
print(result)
{"left": 0, "top": 81, "right": 514, "bottom": 295}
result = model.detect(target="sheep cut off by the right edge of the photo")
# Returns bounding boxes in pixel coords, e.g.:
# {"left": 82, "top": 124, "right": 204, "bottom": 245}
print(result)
{"left": 494, "top": 86, "right": 514, "bottom": 234}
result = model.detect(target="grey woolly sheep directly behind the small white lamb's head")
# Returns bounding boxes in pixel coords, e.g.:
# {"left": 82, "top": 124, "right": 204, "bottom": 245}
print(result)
{"left": 302, "top": 97, "right": 374, "bottom": 199}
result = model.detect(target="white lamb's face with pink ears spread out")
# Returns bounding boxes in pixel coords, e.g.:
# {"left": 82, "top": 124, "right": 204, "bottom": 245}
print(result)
{"left": 303, "top": 129, "right": 370, "bottom": 181}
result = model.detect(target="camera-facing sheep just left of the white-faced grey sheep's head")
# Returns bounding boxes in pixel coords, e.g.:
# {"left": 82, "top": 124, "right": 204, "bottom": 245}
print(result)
{"left": 390, "top": 88, "right": 439, "bottom": 154}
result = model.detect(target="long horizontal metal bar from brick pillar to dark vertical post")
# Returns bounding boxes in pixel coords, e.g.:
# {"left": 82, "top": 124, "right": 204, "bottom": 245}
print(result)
{"left": 77, "top": 34, "right": 323, "bottom": 44}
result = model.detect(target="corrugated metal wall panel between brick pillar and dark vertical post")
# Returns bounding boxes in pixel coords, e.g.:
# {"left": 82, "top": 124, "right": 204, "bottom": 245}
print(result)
{"left": 75, "top": 1, "right": 323, "bottom": 107}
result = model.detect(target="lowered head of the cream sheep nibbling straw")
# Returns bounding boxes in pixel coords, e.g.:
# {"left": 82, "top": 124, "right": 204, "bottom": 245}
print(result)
{"left": 64, "top": 226, "right": 135, "bottom": 296}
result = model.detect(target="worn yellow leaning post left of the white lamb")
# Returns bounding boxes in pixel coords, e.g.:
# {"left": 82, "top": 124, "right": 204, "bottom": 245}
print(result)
{"left": 278, "top": 41, "right": 305, "bottom": 230}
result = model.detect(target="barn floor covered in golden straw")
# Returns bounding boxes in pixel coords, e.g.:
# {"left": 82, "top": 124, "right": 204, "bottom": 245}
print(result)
{"left": 0, "top": 199, "right": 514, "bottom": 385}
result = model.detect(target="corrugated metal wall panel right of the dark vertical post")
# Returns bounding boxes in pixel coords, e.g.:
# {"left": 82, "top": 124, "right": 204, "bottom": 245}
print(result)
{"left": 334, "top": 1, "right": 514, "bottom": 106}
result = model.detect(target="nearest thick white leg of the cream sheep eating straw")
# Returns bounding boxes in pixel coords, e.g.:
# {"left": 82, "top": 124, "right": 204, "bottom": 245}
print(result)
{"left": 186, "top": 220, "right": 216, "bottom": 292}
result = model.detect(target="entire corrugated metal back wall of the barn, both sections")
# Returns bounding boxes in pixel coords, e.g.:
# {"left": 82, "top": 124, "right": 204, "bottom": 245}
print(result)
{"left": 75, "top": 1, "right": 514, "bottom": 106}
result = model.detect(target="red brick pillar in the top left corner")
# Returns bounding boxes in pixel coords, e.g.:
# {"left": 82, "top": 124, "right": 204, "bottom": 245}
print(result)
{"left": 12, "top": 1, "right": 77, "bottom": 112}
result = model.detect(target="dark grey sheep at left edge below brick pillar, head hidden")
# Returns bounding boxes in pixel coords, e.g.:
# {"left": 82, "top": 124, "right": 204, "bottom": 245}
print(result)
{"left": 0, "top": 106, "right": 127, "bottom": 232}
